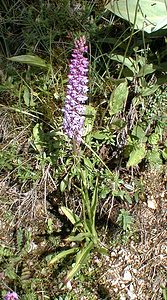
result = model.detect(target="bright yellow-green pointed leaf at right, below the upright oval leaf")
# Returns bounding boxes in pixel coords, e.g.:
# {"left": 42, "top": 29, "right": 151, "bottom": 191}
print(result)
{"left": 127, "top": 144, "right": 146, "bottom": 168}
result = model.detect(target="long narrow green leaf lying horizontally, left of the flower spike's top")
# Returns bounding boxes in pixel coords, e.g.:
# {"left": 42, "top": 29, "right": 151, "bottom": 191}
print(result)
{"left": 8, "top": 55, "right": 48, "bottom": 68}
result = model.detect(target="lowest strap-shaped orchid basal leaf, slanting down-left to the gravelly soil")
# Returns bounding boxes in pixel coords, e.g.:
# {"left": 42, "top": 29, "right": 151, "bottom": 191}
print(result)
{"left": 66, "top": 242, "right": 94, "bottom": 281}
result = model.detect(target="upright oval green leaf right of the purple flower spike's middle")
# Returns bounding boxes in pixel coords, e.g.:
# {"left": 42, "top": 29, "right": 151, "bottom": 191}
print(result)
{"left": 109, "top": 81, "right": 128, "bottom": 115}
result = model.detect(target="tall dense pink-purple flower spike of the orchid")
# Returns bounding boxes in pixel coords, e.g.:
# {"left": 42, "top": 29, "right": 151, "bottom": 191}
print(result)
{"left": 63, "top": 36, "right": 89, "bottom": 144}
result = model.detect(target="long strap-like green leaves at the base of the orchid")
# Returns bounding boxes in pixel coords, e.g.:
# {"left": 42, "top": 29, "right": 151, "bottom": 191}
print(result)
{"left": 49, "top": 176, "right": 107, "bottom": 281}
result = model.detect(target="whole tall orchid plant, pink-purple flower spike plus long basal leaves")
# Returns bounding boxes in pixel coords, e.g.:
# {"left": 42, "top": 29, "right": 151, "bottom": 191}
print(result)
{"left": 49, "top": 36, "right": 106, "bottom": 281}
